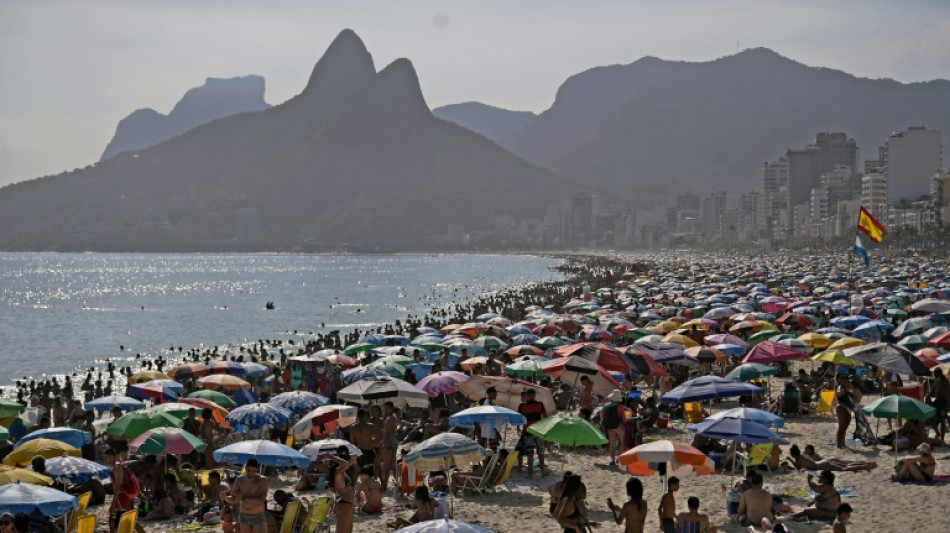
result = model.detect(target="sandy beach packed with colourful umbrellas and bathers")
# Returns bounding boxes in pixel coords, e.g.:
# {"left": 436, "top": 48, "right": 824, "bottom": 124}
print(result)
{"left": 0, "top": 250, "right": 950, "bottom": 533}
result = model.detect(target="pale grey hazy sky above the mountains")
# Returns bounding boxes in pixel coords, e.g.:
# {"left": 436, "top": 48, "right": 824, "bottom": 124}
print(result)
{"left": 0, "top": 0, "right": 950, "bottom": 185}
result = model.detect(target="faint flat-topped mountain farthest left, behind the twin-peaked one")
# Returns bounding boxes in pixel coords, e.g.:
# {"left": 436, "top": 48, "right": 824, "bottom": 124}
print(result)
{"left": 100, "top": 76, "right": 270, "bottom": 161}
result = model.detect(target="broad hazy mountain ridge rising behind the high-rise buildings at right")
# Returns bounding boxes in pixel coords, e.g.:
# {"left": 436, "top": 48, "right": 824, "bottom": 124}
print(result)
{"left": 502, "top": 48, "right": 950, "bottom": 192}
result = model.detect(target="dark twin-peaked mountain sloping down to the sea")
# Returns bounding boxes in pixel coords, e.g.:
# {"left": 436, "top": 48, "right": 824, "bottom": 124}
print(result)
{"left": 0, "top": 30, "right": 579, "bottom": 251}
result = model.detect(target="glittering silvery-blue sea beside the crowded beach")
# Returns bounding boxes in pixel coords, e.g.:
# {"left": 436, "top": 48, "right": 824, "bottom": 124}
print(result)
{"left": 0, "top": 253, "right": 560, "bottom": 386}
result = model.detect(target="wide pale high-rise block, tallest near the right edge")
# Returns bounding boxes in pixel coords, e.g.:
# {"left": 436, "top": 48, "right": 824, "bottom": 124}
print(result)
{"left": 884, "top": 126, "right": 943, "bottom": 203}
